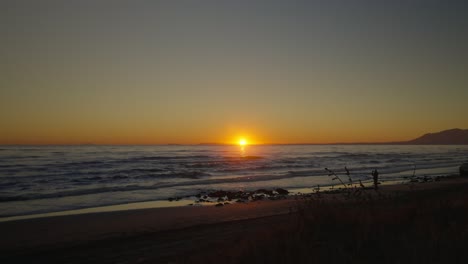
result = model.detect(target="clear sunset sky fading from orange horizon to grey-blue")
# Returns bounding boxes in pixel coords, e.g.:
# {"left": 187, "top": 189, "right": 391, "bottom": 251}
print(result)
{"left": 0, "top": 0, "right": 468, "bottom": 144}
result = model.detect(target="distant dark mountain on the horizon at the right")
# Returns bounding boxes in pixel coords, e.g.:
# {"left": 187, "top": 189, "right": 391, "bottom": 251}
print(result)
{"left": 405, "top": 128, "right": 468, "bottom": 145}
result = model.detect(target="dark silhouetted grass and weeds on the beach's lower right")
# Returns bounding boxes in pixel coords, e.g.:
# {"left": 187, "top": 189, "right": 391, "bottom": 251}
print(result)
{"left": 205, "top": 177, "right": 468, "bottom": 263}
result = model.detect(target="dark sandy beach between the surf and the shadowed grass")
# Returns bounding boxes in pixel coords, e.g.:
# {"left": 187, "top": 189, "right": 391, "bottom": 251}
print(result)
{"left": 0, "top": 174, "right": 468, "bottom": 263}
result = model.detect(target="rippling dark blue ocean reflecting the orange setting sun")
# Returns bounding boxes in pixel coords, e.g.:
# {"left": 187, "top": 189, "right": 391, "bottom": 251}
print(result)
{"left": 0, "top": 145, "right": 468, "bottom": 220}
